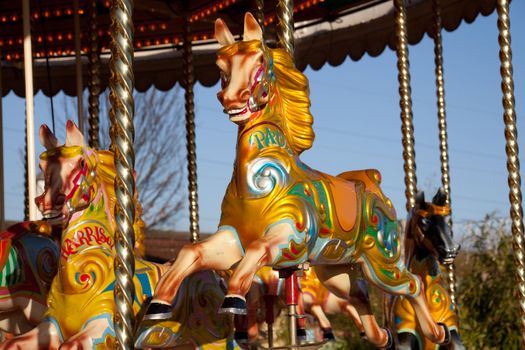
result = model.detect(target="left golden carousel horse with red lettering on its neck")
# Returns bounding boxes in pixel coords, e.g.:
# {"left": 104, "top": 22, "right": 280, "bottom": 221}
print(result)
{"left": 0, "top": 121, "right": 235, "bottom": 350}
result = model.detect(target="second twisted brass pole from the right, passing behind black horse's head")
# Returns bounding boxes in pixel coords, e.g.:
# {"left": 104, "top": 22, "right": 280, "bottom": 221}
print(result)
{"left": 432, "top": 0, "right": 457, "bottom": 311}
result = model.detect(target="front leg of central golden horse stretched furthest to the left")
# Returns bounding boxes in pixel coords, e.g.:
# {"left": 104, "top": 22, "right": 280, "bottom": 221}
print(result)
{"left": 144, "top": 229, "right": 242, "bottom": 320}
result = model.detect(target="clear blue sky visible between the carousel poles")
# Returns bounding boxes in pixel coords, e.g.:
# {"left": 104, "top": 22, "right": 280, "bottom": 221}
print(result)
{"left": 3, "top": 1, "right": 525, "bottom": 232}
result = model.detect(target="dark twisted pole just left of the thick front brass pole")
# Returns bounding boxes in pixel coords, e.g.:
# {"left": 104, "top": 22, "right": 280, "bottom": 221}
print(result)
{"left": 88, "top": 0, "right": 100, "bottom": 149}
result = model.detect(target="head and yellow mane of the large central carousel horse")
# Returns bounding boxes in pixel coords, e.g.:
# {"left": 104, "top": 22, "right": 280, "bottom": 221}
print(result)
{"left": 215, "top": 13, "right": 315, "bottom": 154}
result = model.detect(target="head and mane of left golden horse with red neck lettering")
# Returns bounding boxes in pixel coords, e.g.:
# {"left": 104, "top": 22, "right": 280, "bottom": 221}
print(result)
{"left": 35, "top": 120, "right": 145, "bottom": 252}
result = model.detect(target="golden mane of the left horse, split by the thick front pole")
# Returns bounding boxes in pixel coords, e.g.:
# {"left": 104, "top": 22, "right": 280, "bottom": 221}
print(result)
{"left": 94, "top": 150, "right": 145, "bottom": 256}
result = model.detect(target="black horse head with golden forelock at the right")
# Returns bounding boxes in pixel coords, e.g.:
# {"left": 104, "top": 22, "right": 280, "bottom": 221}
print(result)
{"left": 409, "top": 188, "right": 460, "bottom": 264}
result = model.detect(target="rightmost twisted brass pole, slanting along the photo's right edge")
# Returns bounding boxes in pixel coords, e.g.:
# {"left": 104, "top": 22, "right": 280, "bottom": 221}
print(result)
{"left": 496, "top": 0, "right": 525, "bottom": 347}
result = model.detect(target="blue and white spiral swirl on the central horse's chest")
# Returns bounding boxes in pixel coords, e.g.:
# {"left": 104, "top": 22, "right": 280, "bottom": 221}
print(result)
{"left": 247, "top": 157, "right": 288, "bottom": 198}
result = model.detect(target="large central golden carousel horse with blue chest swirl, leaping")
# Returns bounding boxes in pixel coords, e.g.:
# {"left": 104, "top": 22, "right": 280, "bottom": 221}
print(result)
{"left": 145, "top": 13, "right": 449, "bottom": 347}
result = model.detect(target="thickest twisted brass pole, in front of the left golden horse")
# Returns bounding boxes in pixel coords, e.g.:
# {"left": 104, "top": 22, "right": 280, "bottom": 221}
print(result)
{"left": 110, "top": 0, "right": 135, "bottom": 349}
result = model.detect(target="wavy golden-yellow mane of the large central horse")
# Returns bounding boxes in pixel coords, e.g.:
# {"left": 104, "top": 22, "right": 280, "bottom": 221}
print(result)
{"left": 270, "top": 49, "right": 315, "bottom": 154}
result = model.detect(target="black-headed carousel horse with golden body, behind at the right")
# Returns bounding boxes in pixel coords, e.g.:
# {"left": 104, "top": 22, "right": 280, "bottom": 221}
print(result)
{"left": 390, "top": 189, "right": 465, "bottom": 350}
